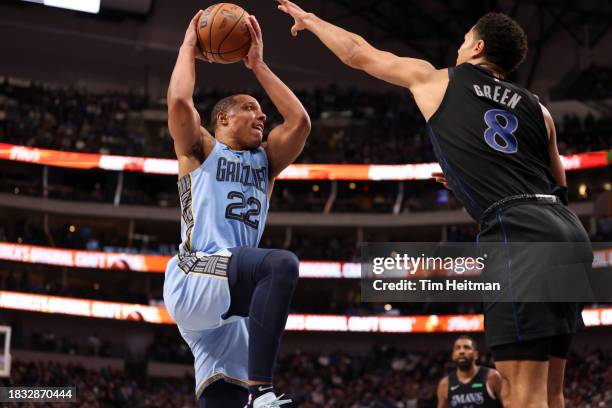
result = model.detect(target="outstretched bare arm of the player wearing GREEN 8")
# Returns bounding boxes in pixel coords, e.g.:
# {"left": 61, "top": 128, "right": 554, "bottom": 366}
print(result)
{"left": 278, "top": 0, "right": 436, "bottom": 90}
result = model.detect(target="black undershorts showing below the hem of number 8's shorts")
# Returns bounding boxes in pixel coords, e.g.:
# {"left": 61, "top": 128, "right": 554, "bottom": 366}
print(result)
{"left": 491, "top": 334, "right": 573, "bottom": 361}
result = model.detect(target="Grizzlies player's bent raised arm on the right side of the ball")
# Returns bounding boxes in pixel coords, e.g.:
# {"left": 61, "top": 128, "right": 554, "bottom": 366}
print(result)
{"left": 244, "top": 16, "right": 310, "bottom": 179}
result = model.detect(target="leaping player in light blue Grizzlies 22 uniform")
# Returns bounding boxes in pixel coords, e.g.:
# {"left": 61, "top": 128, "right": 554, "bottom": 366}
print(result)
{"left": 164, "top": 11, "right": 310, "bottom": 408}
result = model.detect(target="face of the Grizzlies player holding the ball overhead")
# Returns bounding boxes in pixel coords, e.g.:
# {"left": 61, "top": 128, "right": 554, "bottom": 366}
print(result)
{"left": 229, "top": 95, "right": 266, "bottom": 149}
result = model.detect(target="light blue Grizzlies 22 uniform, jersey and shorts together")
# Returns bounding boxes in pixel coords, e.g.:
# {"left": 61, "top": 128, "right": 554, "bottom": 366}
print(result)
{"left": 164, "top": 140, "right": 269, "bottom": 398}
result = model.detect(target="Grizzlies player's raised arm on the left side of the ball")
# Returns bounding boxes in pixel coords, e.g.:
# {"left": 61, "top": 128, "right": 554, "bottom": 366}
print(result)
{"left": 167, "top": 10, "right": 215, "bottom": 177}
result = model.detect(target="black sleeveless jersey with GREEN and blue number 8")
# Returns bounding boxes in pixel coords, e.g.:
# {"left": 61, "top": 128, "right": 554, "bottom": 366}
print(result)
{"left": 428, "top": 64, "right": 559, "bottom": 220}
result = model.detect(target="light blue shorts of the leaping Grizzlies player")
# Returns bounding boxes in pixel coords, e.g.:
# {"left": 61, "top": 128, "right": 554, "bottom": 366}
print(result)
{"left": 164, "top": 250, "right": 248, "bottom": 398}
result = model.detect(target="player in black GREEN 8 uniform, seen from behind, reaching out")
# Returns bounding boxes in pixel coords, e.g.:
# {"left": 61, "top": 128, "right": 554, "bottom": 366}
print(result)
{"left": 278, "top": 0, "right": 592, "bottom": 408}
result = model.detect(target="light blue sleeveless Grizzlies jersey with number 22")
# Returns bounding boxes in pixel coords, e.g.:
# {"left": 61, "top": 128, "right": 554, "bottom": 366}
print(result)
{"left": 179, "top": 141, "right": 268, "bottom": 254}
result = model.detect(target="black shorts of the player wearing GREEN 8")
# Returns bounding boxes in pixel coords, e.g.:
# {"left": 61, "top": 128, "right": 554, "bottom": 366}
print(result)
{"left": 479, "top": 196, "right": 593, "bottom": 348}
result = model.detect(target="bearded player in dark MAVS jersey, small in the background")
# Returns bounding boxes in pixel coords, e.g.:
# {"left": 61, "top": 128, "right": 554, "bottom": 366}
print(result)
{"left": 438, "top": 336, "right": 510, "bottom": 408}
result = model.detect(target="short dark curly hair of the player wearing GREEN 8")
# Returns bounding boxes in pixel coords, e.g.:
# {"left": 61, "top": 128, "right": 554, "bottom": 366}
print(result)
{"left": 474, "top": 13, "right": 528, "bottom": 74}
